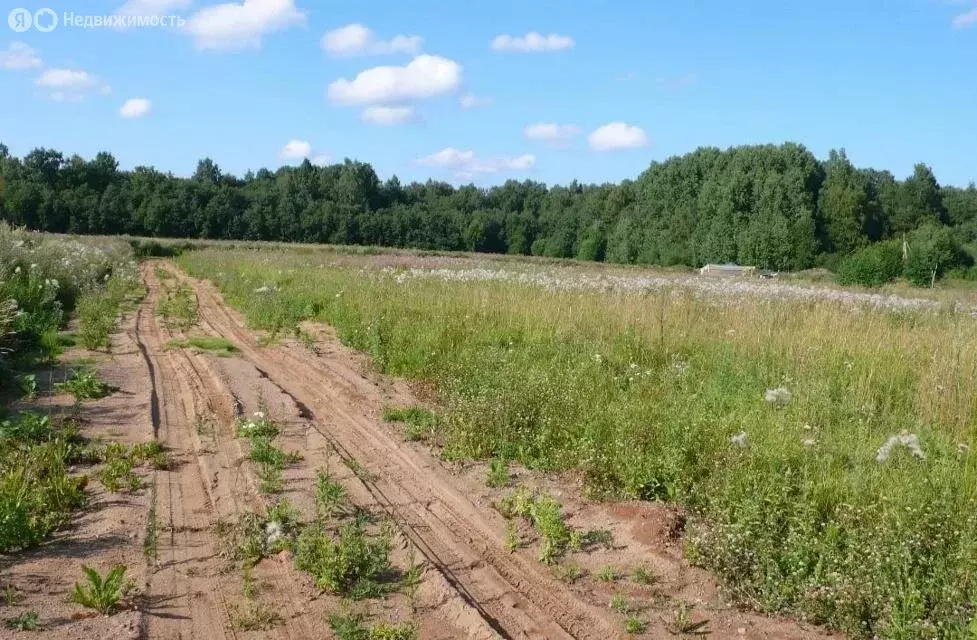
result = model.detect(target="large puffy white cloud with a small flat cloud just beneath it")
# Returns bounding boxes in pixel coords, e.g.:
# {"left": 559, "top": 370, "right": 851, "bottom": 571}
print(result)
{"left": 326, "top": 54, "right": 461, "bottom": 104}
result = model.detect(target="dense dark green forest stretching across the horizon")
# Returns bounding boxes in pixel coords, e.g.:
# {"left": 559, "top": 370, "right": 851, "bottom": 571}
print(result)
{"left": 0, "top": 143, "right": 977, "bottom": 284}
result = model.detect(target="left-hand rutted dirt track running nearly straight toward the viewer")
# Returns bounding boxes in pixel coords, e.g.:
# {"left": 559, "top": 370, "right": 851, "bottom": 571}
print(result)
{"left": 135, "top": 265, "right": 317, "bottom": 640}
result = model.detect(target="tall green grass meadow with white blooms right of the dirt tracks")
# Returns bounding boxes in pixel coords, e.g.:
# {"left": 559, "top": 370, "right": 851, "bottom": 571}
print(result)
{"left": 180, "top": 250, "right": 977, "bottom": 638}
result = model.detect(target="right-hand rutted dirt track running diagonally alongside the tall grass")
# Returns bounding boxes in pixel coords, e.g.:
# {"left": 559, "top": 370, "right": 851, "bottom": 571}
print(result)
{"left": 156, "top": 263, "right": 623, "bottom": 640}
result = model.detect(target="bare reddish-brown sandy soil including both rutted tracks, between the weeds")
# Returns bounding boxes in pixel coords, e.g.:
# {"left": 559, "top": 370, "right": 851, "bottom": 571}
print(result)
{"left": 0, "top": 262, "right": 840, "bottom": 640}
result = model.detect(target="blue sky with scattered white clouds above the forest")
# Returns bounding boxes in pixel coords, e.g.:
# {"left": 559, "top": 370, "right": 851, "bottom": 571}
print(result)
{"left": 0, "top": 0, "right": 977, "bottom": 186}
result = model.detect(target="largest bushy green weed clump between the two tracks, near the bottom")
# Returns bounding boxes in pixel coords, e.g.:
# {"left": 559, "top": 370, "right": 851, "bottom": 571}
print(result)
{"left": 295, "top": 521, "right": 393, "bottom": 600}
